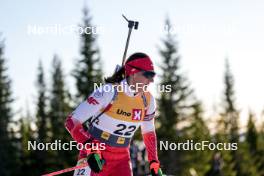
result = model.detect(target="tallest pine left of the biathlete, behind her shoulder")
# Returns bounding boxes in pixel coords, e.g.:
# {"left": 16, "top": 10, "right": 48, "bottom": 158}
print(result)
{"left": 73, "top": 8, "right": 102, "bottom": 102}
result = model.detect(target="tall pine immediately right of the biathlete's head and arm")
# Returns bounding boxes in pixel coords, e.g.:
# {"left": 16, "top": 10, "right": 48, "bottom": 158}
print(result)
{"left": 157, "top": 19, "right": 196, "bottom": 175}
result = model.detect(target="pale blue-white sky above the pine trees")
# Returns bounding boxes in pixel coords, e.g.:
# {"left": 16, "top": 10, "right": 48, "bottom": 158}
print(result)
{"left": 0, "top": 0, "right": 264, "bottom": 129}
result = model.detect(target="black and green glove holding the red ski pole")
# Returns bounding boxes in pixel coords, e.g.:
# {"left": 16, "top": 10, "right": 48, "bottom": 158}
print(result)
{"left": 87, "top": 151, "right": 105, "bottom": 173}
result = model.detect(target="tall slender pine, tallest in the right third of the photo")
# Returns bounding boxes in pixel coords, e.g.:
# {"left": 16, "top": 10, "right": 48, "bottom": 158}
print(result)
{"left": 211, "top": 60, "right": 258, "bottom": 176}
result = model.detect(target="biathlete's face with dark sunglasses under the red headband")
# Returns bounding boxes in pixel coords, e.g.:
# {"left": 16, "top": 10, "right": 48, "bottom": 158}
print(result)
{"left": 130, "top": 71, "right": 155, "bottom": 92}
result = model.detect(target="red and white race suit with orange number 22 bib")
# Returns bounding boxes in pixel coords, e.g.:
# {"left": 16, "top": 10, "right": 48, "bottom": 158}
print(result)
{"left": 66, "top": 80, "right": 158, "bottom": 176}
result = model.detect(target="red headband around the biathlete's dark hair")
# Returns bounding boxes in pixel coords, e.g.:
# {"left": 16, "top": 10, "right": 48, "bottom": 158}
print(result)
{"left": 125, "top": 57, "right": 154, "bottom": 76}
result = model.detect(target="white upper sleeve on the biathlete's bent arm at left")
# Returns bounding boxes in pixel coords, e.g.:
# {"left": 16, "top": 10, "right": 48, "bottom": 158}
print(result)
{"left": 72, "top": 84, "right": 114, "bottom": 123}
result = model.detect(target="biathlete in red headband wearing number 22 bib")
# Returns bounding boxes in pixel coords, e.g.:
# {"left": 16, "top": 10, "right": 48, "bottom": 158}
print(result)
{"left": 65, "top": 53, "right": 162, "bottom": 176}
